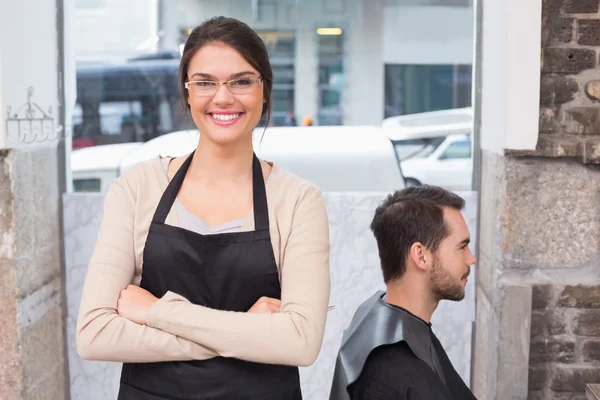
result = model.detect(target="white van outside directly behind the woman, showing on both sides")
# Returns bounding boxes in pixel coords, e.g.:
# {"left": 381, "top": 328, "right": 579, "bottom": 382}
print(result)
{"left": 71, "top": 126, "right": 405, "bottom": 193}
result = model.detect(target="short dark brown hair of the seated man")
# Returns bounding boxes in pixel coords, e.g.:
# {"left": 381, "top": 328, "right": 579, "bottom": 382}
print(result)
{"left": 371, "top": 185, "right": 465, "bottom": 284}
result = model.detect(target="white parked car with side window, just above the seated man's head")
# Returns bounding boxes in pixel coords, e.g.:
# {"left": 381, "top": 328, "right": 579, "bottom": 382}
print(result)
{"left": 400, "top": 134, "right": 473, "bottom": 190}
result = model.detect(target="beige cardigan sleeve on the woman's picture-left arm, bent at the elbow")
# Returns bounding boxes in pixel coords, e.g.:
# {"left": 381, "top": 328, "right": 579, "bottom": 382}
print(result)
{"left": 76, "top": 179, "right": 217, "bottom": 362}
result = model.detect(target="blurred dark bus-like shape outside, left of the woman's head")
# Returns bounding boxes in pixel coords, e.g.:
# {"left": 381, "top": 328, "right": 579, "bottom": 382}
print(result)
{"left": 73, "top": 59, "right": 193, "bottom": 149}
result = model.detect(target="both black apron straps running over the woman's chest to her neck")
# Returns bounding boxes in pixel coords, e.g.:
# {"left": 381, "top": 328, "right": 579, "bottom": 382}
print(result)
{"left": 152, "top": 150, "right": 269, "bottom": 232}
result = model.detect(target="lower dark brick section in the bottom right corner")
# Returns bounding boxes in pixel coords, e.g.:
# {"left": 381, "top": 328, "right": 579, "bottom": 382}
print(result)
{"left": 529, "top": 284, "right": 600, "bottom": 400}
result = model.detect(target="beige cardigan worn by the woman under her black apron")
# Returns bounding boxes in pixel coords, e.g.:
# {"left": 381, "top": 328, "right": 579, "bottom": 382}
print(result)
{"left": 77, "top": 157, "right": 330, "bottom": 366}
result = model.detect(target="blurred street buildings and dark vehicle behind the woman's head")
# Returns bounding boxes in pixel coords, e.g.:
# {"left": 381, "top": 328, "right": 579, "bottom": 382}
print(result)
{"left": 72, "top": 0, "right": 473, "bottom": 148}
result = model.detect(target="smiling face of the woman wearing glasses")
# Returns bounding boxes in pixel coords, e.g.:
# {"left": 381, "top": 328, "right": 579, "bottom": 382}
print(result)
{"left": 187, "top": 42, "right": 265, "bottom": 144}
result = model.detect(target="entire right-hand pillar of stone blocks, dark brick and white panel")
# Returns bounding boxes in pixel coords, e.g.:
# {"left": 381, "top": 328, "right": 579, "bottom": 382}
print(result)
{"left": 474, "top": 0, "right": 600, "bottom": 400}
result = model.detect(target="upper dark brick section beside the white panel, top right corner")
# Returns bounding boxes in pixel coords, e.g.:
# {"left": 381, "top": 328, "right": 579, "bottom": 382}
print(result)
{"left": 515, "top": 0, "right": 600, "bottom": 164}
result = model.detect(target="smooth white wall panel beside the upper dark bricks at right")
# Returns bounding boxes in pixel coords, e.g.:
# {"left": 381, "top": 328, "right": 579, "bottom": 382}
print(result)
{"left": 480, "top": 0, "right": 542, "bottom": 154}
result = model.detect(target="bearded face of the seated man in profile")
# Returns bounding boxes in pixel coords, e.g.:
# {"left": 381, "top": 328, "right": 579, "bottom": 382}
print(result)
{"left": 429, "top": 208, "right": 476, "bottom": 301}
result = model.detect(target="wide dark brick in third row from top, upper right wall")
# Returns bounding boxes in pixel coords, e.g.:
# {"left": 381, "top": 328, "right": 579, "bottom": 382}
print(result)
{"left": 542, "top": 47, "right": 596, "bottom": 74}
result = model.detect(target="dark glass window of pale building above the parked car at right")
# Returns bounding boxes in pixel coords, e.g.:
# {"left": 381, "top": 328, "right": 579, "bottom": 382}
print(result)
{"left": 385, "top": 64, "right": 472, "bottom": 118}
